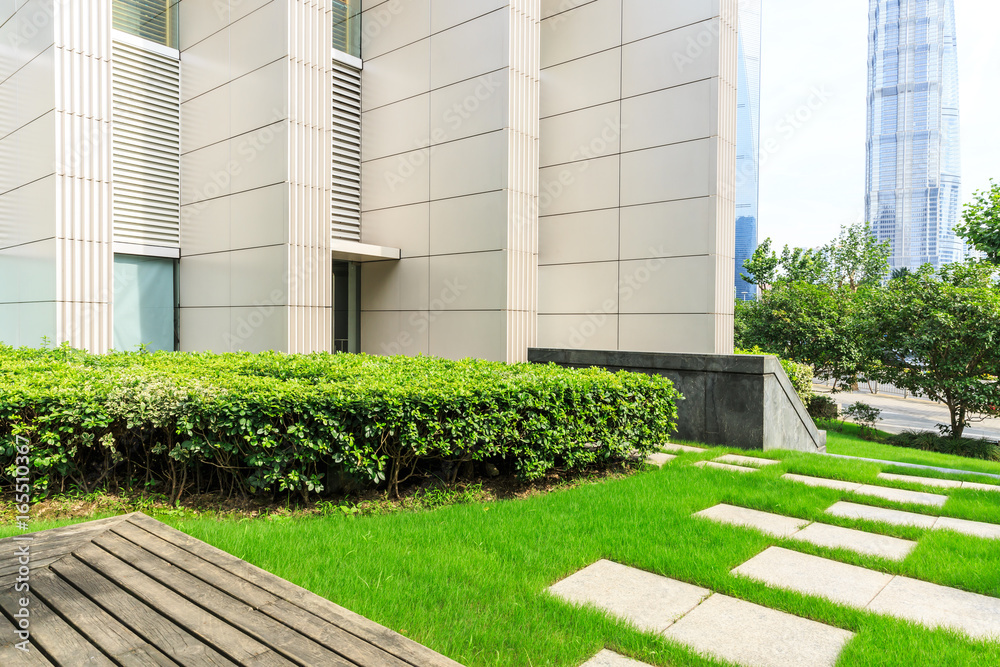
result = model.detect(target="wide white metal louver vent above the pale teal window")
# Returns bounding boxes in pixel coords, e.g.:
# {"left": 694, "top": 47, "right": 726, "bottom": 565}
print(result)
{"left": 112, "top": 42, "right": 181, "bottom": 247}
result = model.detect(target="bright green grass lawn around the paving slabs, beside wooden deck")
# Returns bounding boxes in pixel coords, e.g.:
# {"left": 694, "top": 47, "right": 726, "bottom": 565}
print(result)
{"left": 0, "top": 432, "right": 1000, "bottom": 667}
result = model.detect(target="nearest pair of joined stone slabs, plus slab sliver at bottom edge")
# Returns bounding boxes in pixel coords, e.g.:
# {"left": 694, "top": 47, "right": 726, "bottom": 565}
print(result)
{"left": 549, "top": 560, "right": 854, "bottom": 667}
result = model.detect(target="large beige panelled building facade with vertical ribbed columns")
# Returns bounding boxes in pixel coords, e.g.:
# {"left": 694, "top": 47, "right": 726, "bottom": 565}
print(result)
{"left": 0, "top": 0, "right": 737, "bottom": 361}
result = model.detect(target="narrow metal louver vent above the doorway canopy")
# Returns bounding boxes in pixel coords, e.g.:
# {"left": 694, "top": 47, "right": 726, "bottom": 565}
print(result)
{"left": 332, "top": 62, "right": 361, "bottom": 242}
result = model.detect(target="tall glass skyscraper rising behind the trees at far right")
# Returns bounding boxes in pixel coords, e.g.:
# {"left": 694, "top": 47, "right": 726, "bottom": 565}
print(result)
{"left": 865, "top": 0, "right": 965, "bottom": 269}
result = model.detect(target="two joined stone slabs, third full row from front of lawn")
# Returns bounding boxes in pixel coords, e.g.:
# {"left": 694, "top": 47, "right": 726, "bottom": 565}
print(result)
{"left": 695, "top": 504, "right": 917, "bottom": 560}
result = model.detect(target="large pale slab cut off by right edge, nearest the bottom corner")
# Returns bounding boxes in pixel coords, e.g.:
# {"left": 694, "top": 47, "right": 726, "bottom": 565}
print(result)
{"left": 868, "top": 577, "right": 1000, "bottom": 639}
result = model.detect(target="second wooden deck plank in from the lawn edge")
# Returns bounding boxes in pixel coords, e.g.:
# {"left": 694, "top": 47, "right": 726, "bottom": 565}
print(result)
{"left": 112, "top": 523, "right": 408, "bottom": 667}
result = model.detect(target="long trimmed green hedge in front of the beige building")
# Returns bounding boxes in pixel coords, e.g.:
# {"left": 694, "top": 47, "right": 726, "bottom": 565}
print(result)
{"left": 0, "top": 345, "right": 679, "bottom": 501}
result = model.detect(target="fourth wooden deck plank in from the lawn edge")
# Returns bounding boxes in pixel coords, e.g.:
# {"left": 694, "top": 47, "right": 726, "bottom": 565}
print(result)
{"left": 74, "top": 544, "right": 294, "bottom": 667}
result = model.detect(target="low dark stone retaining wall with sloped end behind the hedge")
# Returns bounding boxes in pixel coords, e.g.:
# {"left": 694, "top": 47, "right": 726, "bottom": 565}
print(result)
{"left": 528, "top": 348, "right": 826, "bottom": 452}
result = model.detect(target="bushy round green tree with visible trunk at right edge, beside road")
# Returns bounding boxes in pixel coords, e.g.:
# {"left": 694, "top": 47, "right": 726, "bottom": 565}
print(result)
{"left": 856, "top": 262, "right": 1000, "bottom": 437}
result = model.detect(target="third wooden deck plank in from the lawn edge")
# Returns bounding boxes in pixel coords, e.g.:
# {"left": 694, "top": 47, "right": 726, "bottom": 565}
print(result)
{"left": 94, "top": 533, "right": 362, "bottom": 667}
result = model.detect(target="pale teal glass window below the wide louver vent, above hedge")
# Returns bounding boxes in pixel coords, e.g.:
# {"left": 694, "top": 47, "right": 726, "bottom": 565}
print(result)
{"left": 113, "top": 255, "right": 176, "bottom": 352}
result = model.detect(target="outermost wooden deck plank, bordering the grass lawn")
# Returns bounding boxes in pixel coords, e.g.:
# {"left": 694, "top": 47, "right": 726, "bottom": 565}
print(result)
{"left": 129, "top": 514, "right": 462, "bottom": 667}
